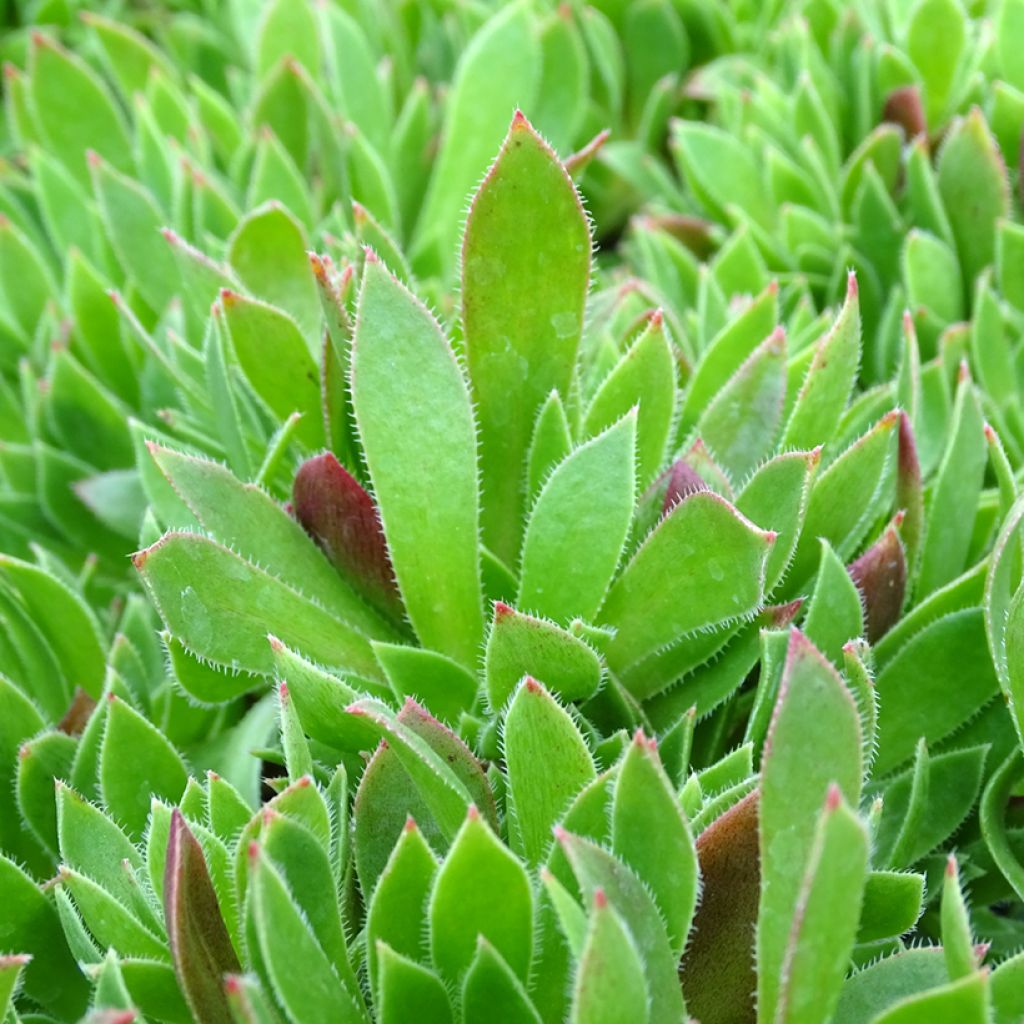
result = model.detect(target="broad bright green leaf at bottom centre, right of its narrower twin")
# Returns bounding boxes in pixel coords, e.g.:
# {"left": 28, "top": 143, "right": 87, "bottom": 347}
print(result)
{"left": 429, "top": 807, "right": 534, "bottom": 984}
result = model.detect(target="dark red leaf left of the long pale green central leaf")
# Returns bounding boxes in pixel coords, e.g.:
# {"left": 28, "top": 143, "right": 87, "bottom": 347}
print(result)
{"left": 293, "top": 452, "right": 401, "bottom": 615}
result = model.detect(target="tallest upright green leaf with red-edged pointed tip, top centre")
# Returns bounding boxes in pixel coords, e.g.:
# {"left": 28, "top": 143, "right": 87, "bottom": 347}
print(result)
{"left": 460, "top": 115, "right": 591, "bottom": 563}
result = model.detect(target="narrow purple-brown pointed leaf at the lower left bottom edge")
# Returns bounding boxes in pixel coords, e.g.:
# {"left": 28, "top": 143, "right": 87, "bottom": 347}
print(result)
{"left": 164, "top": 808, "right": 242, "bottom": 1024}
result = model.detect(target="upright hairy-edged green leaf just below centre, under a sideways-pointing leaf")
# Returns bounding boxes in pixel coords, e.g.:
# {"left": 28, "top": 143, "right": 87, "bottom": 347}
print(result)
{"left": 502, "top": 676, "right": 596, "bottom": 866}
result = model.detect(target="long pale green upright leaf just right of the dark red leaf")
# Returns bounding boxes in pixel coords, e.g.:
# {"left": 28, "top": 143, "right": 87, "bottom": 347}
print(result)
{"left": 352, "top": 261, "right": 483, "bottom": 668}
